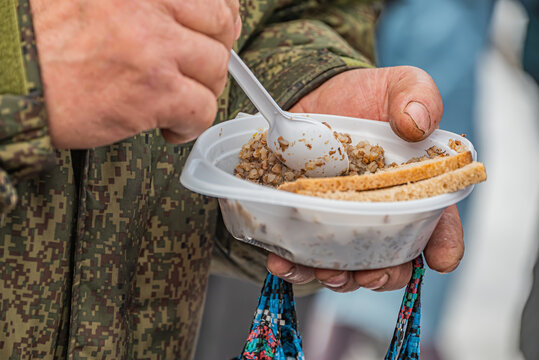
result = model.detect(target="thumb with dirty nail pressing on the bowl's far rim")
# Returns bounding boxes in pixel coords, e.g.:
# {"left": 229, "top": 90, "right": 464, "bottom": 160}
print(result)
{"left": 290, "top": 66, "right": 443, "bottom": 141}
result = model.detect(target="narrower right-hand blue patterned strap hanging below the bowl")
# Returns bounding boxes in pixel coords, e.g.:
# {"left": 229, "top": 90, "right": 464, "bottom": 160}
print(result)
{"left": 385, "top": 255, "right": 425, "bottom": 360}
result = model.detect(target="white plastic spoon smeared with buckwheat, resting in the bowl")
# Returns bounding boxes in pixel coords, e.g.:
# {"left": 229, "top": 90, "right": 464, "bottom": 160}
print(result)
{"left": 228, "top": 50, "right": 349, "bottom": 177}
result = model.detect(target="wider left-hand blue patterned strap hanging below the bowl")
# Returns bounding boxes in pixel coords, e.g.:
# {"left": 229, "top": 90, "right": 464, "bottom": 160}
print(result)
{"left": 236, "top": 273, "right": 305, "bottom": 360}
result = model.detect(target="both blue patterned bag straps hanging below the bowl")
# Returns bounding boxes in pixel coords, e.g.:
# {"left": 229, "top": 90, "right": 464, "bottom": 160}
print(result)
{"left": 235, "top": 255, "right": 425, "bottom": 360}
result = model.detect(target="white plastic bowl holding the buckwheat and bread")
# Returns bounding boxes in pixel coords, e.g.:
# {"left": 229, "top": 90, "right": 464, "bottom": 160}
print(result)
{"left": 180, "top": 114, "right": 477, "bottom": 270}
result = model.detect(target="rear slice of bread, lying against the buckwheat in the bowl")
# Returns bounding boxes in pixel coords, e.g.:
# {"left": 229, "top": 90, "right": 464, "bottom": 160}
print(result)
{"left": 279, "top": 151, "right": 473, "bottom": 195}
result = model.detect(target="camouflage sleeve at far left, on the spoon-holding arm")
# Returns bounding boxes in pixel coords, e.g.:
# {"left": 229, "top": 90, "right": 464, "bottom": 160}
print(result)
{"left": 0, "top": 0, "right": 55, "bottom": 215}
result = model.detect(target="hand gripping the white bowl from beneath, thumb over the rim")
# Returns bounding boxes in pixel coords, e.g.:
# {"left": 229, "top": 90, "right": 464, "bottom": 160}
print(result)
{"left": 266, "top": 66, "right": 464, "bottom": 292}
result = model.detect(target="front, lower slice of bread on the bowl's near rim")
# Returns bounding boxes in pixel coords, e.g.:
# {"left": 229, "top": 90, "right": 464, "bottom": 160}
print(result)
{"left": 300, "top": 162, "right": 487, "bottom": 202}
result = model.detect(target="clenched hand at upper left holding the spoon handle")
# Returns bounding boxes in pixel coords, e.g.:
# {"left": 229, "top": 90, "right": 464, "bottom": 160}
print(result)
{"left": 31, "top": 0, "right": 241, "bottom": 148}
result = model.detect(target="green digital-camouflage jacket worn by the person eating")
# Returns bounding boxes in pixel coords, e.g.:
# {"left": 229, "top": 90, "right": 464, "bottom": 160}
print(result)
{"left": 0, "top": 0, "right": 375, "bottom": 359}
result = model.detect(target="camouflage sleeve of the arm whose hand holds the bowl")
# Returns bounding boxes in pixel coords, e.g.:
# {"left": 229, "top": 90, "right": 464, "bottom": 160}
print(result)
{"left": 212, "top": 1, "right": 377, "bottom": 294}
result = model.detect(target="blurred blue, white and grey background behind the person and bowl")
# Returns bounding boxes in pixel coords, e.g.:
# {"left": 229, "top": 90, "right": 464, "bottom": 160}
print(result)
{"left": 195, "top": 0, "right": 539, "bottom": 360}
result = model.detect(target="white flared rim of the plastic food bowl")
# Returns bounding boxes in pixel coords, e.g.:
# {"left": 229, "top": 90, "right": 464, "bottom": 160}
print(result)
{"left": 180, "top": 114, "right": 477, "bottom": 215}
